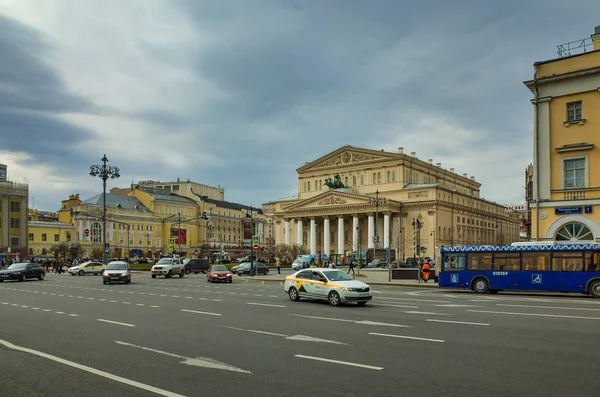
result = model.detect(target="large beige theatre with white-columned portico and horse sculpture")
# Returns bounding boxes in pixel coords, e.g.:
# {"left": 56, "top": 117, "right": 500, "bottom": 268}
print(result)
{"left": 263, "top": 146, "right": 519, "bottom": 259}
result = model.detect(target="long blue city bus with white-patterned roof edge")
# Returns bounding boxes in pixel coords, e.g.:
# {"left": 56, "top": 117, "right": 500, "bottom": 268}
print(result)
{"left": 439, "top": 243, "right": 600, "bottom": 298}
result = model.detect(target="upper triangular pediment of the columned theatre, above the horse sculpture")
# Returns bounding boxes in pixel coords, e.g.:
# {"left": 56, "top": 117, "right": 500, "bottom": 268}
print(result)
{"left": 297, "top": 146, "right": 398, "bottom": 172}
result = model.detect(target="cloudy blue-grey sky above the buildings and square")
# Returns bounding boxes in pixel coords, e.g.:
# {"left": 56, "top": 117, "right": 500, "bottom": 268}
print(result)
{"left": 0, "top": 0, "right": 600, "bottom": 210}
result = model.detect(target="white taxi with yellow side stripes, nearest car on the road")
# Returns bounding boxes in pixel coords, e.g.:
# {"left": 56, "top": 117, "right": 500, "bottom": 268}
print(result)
{"left": 283, "top": 269, "right": 373, "bottom": 306}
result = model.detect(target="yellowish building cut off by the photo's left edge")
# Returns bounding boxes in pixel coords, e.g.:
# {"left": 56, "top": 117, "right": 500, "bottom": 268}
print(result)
{"left": 0, "top": 169, "right": 29, "bottom": 259}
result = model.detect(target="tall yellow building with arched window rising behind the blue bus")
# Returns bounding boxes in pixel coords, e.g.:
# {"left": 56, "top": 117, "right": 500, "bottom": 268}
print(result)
{"left": 525, "top": 26, "right": 600, "bottom": 241}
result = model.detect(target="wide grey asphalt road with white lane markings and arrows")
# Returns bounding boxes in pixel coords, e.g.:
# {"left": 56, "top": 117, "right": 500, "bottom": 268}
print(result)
{"left": 0, "top": 274, "right": 600, "bottom": 397}
